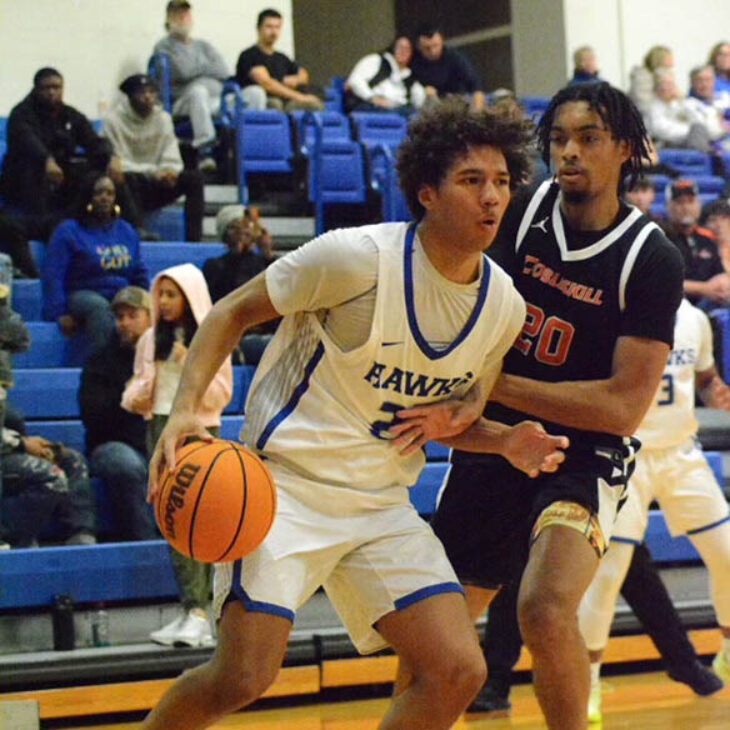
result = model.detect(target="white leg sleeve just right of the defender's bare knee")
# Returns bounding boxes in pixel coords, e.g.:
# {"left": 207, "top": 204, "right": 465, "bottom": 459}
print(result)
{"left": 578, "top": 542, "right": 634, "bottom": 651}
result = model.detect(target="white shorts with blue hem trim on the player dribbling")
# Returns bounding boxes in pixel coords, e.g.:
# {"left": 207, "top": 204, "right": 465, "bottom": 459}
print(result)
{"left": 213, "top": 462, "right": 463, "bottom": 654}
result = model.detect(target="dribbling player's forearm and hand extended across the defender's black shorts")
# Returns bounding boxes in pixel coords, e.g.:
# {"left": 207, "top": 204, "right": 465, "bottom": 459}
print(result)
{"left": 441, "top": 418, "right": 570, "bottom": 477}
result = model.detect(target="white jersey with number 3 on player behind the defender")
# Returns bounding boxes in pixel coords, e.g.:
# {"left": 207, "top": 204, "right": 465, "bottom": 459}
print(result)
{"left": 636, "top": 299, "right": 714, "bottom": 449}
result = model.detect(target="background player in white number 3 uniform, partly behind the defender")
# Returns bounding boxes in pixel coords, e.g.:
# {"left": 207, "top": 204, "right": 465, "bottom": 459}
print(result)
{"left": 579, "top": 299, "right": 730, "bottom": 722}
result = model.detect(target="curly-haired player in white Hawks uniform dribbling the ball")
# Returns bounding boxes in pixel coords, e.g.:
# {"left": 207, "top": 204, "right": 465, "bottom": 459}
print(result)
{"left": 138, "top": 98, "right": 567, "bottom": 730}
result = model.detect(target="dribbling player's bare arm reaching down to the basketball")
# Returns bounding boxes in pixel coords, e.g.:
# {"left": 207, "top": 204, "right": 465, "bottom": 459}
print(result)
{"left": 147, "top": 273, "right": 279, "bottom": 501}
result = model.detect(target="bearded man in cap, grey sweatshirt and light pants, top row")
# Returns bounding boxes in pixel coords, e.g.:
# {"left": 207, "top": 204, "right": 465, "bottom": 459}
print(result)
{"left": 153, "top": 0, "right": 229, "bottom": 170}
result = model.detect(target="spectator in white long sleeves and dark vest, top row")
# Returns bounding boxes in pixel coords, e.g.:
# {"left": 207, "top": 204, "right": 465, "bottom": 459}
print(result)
{"left": 345, "top": 36, "right": 426, "bottom": 116}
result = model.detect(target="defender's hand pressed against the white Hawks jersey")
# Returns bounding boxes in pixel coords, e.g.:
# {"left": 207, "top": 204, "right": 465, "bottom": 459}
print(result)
{"left": 388, "top": 399, "right": 481, "bottom": 456}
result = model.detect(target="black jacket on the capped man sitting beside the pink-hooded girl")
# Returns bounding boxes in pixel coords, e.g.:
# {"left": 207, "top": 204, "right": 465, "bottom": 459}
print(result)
{"left": 79, "top": 332, "right": 147, "bottom": 455}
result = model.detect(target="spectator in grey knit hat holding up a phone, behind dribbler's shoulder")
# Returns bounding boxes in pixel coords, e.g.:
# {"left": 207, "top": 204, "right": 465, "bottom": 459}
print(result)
{"left": 203, "top": 205, "right": 276, "bottom": 365}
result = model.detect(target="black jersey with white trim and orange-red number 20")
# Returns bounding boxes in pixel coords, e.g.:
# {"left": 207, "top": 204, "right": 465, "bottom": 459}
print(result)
{"left": 454, "top": 181, "right": 682, "bottom": 461}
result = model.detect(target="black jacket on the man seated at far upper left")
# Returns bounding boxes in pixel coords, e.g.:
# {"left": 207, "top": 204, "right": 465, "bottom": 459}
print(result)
{"left": 0, "top": 92, "right": 112, "bottom": 212}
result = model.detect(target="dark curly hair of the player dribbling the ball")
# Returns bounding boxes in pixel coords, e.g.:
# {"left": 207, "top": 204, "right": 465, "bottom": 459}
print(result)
{"left": 397, "top": 97, "right": 533, "bottom": 221}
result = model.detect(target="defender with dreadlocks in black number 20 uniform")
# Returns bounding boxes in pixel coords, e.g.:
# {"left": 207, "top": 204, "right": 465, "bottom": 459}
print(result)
{"left": 392, "top": 83, "right": 682, "bottom": 730}
